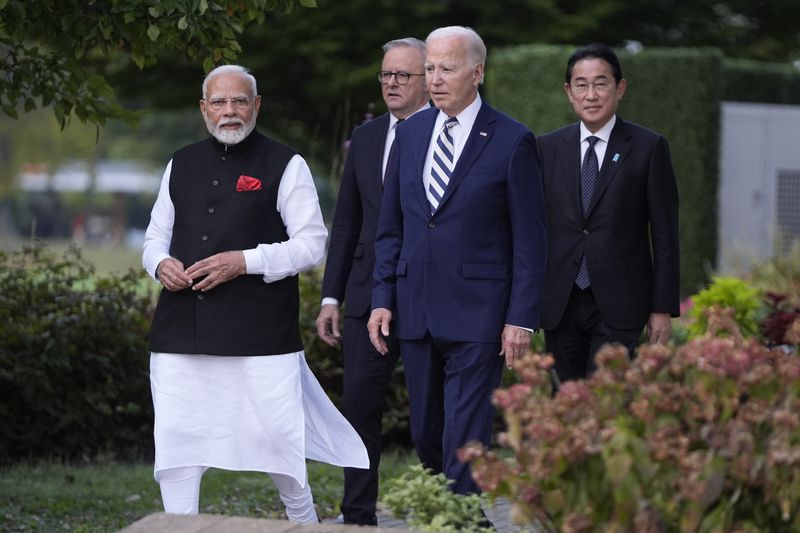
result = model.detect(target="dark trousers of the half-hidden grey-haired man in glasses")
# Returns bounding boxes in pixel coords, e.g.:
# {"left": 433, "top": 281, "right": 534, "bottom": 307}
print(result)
{"left": 341, "top": 317, "right": 400, "bottom": 526}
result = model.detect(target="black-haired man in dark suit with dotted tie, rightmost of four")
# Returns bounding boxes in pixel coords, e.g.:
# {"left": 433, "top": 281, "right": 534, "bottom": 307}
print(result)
{"left": 539, "top": 44, "right": 680, "bottom": 383}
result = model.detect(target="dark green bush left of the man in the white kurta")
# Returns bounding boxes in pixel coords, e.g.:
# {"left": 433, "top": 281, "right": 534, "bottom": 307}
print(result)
{"left": 0, "top": 245, "right": 153, "bottom": 462}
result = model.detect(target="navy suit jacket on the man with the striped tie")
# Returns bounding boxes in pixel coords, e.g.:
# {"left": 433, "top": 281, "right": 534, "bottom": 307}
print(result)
{"left": 372, "top": 102, "right": 547, "bottom": 343}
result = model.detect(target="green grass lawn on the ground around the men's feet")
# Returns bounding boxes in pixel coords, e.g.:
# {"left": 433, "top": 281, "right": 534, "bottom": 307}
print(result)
{"left": 0, "top": 451, "right": 418, "bottom": 533}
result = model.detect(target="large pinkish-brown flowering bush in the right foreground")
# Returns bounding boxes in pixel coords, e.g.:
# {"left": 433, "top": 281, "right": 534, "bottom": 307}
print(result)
{"left": 459, "top": 308, "right": 800, "bottom": 533}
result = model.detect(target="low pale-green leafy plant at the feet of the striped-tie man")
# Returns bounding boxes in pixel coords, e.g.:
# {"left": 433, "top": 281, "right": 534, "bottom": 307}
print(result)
{"left": 382, "top": 464, "right": 493, "bottom": 533}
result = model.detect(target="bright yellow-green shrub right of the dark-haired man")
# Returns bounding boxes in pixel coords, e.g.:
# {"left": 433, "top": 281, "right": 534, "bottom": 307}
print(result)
{"left": 689, "top": 276, "right": 762, "bottom": 338}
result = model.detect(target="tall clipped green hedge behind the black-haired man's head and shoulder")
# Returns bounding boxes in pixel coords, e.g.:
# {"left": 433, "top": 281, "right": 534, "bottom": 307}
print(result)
{"left": 484, "top": 45, "right": 723, "bottom": 296}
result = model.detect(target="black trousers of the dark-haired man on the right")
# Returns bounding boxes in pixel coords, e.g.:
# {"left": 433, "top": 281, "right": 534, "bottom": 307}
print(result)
{"left": 544, "top": 285, "right": 642, "bottom": 381}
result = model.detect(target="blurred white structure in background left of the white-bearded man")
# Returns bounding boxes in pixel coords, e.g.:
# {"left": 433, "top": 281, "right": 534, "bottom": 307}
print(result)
{"left": 18, "top": 161, "right": 161, "bottom": 194}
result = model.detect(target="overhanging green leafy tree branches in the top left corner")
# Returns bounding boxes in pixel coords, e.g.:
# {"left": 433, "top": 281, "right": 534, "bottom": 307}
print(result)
{"left": 0, "top": 0, "right": 316, "bottom": 128}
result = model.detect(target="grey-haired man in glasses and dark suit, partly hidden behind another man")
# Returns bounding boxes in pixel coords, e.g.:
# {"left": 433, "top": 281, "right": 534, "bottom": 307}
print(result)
{"left": 317, "top": 37, "right": 430, "bottom": 525}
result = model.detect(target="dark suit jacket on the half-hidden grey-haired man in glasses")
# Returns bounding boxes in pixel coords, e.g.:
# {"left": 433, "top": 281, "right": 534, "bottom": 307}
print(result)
{"left": 322, "top": 113, "right": 389, "bottom": 317}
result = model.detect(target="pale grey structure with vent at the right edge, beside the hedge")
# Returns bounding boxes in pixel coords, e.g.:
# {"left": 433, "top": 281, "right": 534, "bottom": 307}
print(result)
{"left": 717, "top": 102, "right": 800, "bottom": 273}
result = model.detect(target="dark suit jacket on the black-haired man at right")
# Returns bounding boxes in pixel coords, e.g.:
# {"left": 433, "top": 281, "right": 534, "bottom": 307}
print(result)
{"left": 539, "top": 117, "right": 680, "bottom": 329}
